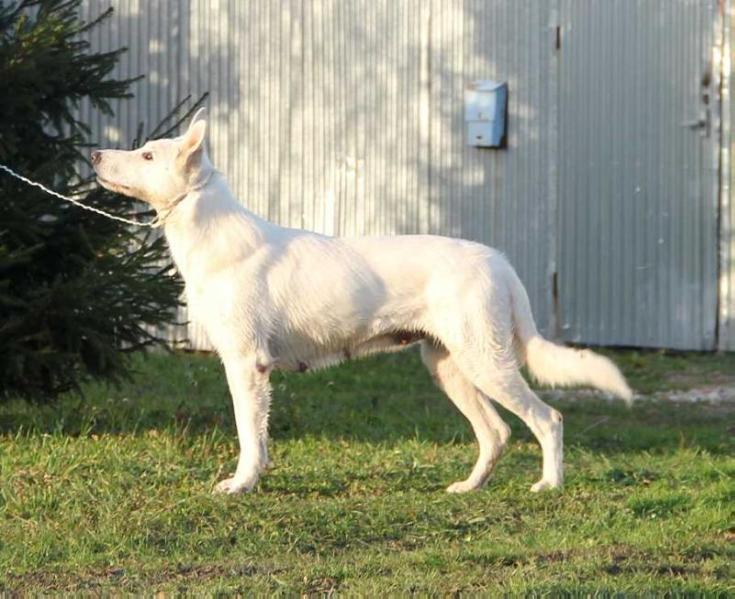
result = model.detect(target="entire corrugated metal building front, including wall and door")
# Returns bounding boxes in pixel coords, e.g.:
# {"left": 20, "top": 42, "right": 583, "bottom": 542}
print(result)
{"left": 77, "top": 0, "right": 735, "bottom": 349}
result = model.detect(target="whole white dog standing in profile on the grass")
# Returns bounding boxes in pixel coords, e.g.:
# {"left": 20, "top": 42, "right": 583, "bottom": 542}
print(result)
{"left": 92, "top": 112, "right": 631, "bottom": 493}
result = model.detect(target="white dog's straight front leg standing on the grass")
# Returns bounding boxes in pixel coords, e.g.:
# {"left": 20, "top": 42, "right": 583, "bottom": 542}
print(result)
{"left": 215, "top": 355, "right": 271, "bottom": 493}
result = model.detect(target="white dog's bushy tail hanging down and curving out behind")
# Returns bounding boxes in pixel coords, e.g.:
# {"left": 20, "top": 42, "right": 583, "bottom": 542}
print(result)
{"left": 510, "top": 269, "right": 633, "bottom": 405}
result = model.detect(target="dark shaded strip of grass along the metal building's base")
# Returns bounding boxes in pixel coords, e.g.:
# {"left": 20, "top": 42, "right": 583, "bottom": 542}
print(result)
{"left": 0, "top": 351, "right": 735, "bottom": 453}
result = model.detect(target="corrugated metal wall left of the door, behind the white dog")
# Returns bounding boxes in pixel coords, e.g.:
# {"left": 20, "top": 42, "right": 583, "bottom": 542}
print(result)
{"left": 83, "top": 0, "right": 554, "bottom": 345}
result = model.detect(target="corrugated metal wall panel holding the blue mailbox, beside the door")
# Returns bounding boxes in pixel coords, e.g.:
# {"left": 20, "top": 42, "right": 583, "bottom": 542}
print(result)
{"left": 427, "top": 0, "right": 557, "bottom": 332}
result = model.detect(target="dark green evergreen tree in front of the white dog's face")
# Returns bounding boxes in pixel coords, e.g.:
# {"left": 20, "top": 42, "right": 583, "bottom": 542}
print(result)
{"left": 0, "top": 0, "right": 186, "bottom": 400}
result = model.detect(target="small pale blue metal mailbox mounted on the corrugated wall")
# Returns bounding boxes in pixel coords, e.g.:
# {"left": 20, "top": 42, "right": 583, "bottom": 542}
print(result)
{"left": 464, "top": 79, "right": 508, "bottom": 148}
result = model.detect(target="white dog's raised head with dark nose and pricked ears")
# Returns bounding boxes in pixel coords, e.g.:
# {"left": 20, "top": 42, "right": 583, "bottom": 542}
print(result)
{"left": 91, "top": 110, "right": 212, "bottom": 209}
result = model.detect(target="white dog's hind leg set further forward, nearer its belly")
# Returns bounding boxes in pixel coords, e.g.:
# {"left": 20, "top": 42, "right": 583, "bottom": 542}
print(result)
{"left": 421, "top": 341, "right": 510, "bottom": 493}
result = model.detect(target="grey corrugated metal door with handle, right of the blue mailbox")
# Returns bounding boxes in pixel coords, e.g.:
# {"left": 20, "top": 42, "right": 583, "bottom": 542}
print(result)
{"left": 557, "top": 0, "right": 719, "bottom": 349}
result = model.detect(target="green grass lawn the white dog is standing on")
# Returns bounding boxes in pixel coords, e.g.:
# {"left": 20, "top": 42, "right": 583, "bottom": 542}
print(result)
{"left": 0, "top": 352, "right": 735, "bottom": 596}
